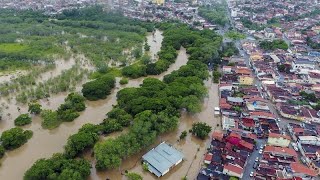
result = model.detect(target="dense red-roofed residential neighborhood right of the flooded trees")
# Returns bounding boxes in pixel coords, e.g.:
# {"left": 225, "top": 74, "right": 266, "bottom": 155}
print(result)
{"left": 198, "top": 0, "right": 320, "bottom": 180}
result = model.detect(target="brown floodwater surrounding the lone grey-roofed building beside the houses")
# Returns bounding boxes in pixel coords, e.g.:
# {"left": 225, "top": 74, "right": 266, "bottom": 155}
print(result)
{"left": 85, "top": 81, "right": 221, "bottom": 180}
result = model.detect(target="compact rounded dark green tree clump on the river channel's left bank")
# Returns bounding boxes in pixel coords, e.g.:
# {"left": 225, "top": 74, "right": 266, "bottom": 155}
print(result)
{"left": 82, "top": 75, "right": 116, "bottom": 101}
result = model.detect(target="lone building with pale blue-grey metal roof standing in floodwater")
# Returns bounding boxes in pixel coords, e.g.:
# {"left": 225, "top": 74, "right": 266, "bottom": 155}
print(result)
{"left": 142, "top": 142, "right": 184, "bottom": 177}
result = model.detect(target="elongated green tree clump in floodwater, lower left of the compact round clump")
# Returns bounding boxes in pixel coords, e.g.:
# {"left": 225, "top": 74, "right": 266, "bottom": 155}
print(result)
{"left": 41, "top": 93, "right": 86, "bottom": 129}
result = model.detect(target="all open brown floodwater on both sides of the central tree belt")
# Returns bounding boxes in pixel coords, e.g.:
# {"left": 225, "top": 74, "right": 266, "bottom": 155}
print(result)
{"left": 0, "top": 31, "right": 220, "bottom": 180}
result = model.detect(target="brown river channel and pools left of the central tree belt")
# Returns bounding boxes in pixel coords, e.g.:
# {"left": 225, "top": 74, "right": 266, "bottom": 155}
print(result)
{"left": 0, "top": 30, "right": 180, "bottom": 180}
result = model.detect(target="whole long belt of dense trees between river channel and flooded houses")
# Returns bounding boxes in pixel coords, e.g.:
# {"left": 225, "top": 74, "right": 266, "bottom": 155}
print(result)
{"left": 25, "top": 11, "right": 222, "bottom": 176}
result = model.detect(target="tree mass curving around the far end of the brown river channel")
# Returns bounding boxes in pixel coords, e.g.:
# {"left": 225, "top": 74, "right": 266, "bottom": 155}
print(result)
{"left": 122, "top": 23, "right": 222, "bottom": 78}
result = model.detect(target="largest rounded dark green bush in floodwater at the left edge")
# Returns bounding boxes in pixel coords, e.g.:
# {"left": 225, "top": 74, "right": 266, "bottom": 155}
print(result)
{"left": 0, "top": 128, "right": 32, "bottom": 150}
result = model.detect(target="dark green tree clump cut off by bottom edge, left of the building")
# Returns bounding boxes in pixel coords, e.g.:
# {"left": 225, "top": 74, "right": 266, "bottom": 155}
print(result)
{"left": 23, "top": 154, "right": 91, "bottom": 180}
